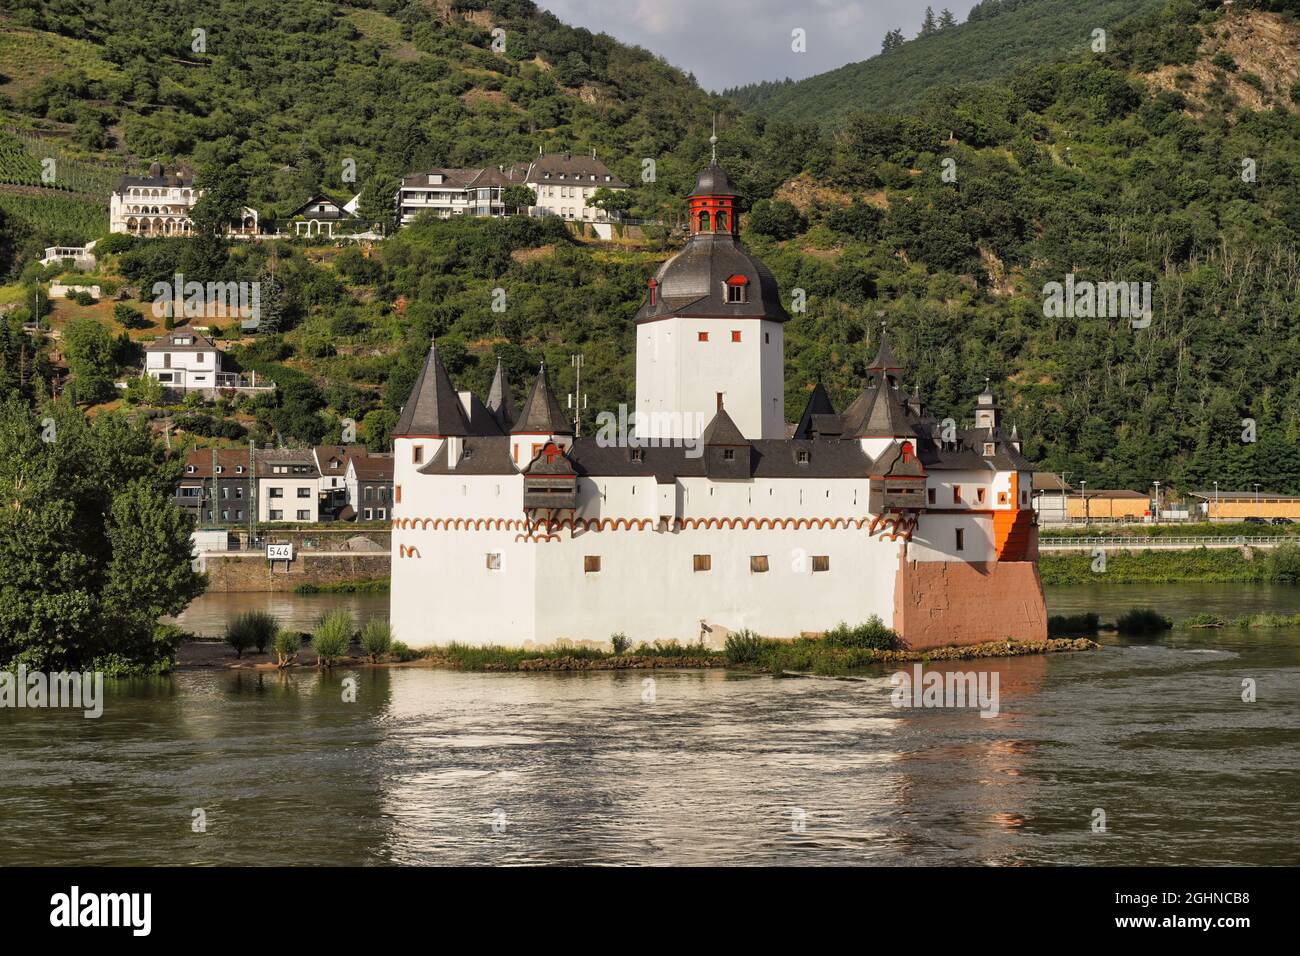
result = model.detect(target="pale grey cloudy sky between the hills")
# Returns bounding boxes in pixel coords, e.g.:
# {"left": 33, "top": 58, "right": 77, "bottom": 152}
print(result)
{"left": 537, "top": 0, "right": 975, "bottom": 90}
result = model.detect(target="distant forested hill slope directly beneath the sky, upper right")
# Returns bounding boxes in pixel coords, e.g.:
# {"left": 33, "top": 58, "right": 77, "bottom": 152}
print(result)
{"left": 724, "top": 0, "right": 1162, "bottom": 126}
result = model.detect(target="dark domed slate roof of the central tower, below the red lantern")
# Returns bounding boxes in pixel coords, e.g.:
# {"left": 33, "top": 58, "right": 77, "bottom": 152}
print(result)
{"left": 636, "top": 233, "right": 790, "bottom": 323}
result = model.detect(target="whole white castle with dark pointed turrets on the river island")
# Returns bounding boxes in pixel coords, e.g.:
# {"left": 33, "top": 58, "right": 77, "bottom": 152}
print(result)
{"left": 390, "top": 159, "right": 1047, "bottom": 648}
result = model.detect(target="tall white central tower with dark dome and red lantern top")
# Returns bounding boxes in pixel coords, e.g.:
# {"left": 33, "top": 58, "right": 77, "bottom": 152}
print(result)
{"left": 636, "top": 159, "right": 789, "bottom": 438}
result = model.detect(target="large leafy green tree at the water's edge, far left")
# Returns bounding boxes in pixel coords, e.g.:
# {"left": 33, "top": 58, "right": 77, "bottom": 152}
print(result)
{"left": 0, "top": 399, "right": 203, "bottom": 670}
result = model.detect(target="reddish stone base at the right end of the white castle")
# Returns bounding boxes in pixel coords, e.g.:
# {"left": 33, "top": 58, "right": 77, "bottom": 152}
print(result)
{"left": 893, "top": 558, "right": 1048, "bottom": 650}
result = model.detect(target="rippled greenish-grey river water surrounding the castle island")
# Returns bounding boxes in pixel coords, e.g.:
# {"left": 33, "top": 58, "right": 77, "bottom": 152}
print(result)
{"left": 0, "top": 585, "right": 1300, "bottom": 865}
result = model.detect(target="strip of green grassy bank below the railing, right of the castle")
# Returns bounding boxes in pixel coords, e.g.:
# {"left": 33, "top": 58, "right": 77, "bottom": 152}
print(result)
{"left": 1039, "top": 544, "right": 1300, "bottom": 585}
